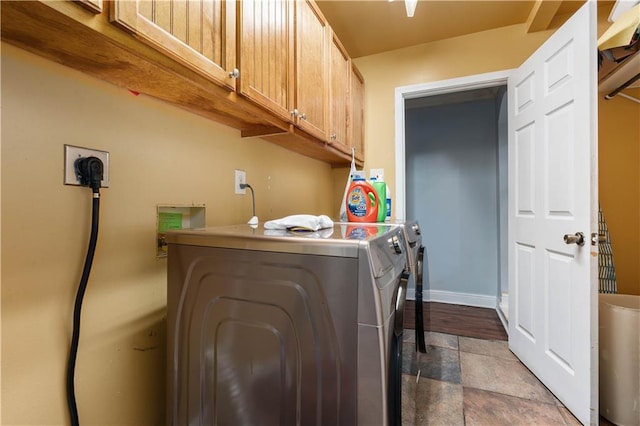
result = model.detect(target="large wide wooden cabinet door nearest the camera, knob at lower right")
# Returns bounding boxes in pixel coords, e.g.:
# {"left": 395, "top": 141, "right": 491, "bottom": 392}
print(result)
{"left": 111, "top": 0, "right": 236, "bottom": 90}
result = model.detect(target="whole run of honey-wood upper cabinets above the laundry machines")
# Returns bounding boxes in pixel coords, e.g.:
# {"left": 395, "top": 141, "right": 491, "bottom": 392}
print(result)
{"left": 0, "top": 0, "right": 364, "bottom": 167}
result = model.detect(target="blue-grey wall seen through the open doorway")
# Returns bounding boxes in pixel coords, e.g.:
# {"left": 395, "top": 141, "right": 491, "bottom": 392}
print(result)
{"left": 405, "top": 99, "right": 506, "bottom": 297}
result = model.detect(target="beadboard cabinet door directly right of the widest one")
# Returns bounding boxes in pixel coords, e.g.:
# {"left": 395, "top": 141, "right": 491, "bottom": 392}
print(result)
{"left": 238, "top": 0, "right": 294, "bottom": 120}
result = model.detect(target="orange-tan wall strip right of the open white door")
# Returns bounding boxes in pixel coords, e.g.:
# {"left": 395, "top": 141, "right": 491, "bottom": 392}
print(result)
{"left": 598, "top": 89, "right": 640, "bottom": 295}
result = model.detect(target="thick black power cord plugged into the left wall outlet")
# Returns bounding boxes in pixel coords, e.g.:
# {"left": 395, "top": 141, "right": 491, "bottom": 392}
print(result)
{"left": 67, "top": 157, "right": 104, "bottom": 426}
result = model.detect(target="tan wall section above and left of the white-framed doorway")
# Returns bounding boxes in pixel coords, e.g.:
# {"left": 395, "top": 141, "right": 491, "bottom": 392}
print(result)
{"left": 355, "top": 25, "right": 552, "bottom": 216}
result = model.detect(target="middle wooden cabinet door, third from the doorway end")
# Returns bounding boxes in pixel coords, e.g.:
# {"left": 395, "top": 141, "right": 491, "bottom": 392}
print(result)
{"left": 295, "top": 0, "right": 329, "bottom": 140}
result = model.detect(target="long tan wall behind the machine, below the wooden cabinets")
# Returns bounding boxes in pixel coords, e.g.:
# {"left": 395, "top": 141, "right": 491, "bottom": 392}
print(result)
{"left": 1, "top": 44, "right": 337, "bottom": 425}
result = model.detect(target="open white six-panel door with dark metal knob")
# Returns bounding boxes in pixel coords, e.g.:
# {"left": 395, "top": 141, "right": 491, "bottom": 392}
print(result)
{"left": 508, "top": 1, "right": 598, "bottom": 424}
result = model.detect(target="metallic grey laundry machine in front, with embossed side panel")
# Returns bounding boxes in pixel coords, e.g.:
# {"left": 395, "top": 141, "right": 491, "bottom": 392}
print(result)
{"left": 167, "top": 224, "right": 413, "bottom": 426}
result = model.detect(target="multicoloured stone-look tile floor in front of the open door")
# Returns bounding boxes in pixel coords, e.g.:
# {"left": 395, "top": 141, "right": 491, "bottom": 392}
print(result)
{"left": 402, "top": 330, "right": 580, "bottom": 426}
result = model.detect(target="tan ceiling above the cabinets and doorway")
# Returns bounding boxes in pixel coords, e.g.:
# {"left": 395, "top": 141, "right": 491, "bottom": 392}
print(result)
{"left": 316, "top": 0, "right": 600, "bottom": 58}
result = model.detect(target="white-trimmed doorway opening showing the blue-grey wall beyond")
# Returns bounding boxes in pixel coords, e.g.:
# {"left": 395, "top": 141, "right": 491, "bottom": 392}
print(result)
{"left": 396, "top": 71, "right": 509, "bottom": 318}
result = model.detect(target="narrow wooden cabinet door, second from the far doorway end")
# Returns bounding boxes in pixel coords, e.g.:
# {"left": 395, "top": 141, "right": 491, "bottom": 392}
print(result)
{"left": 328, "top": 31, "right": 351, "bottom": 154}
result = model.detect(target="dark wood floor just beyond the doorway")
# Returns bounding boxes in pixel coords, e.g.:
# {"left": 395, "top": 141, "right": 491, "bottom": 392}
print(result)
{"left": 404, "top": 300, "right": 507, "bottom": 340}
